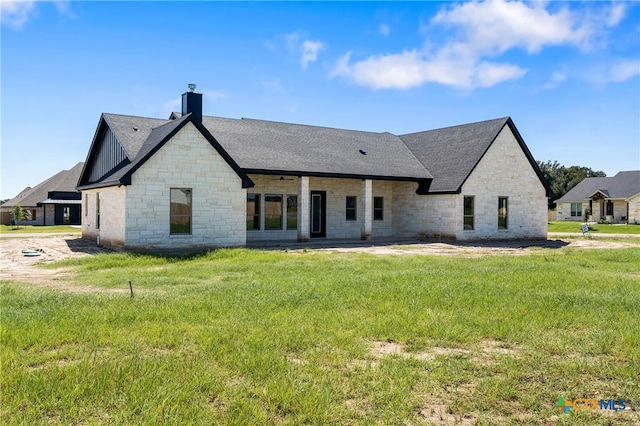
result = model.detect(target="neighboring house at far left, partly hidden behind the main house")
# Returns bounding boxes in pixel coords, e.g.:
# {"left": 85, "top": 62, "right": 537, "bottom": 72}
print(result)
{"left": 0, "top": 162, "right": 84, "bottom": 225}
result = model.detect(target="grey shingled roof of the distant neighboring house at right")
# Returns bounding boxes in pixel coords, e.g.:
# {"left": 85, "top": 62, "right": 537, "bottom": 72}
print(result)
{"left": 555, "top": 170, "right": 640, "bottom": 203}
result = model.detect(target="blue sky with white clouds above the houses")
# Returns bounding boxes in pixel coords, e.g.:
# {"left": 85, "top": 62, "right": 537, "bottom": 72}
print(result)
{"left": 0, "top": 0, "right": 640, "bottom": 198}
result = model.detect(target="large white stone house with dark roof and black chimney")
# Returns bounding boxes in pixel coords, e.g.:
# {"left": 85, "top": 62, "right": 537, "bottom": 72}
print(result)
{"left": 78, "top": 91, "right": 549, "bottom": 249}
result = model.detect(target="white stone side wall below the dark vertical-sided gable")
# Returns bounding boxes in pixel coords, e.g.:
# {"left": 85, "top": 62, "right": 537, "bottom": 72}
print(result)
{"left": 80, "top": 186, "right": 126, "bottom": 248}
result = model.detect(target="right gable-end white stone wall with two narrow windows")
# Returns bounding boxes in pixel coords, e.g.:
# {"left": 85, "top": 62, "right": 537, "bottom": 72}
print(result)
{"left": 458, "top": 127, "right": 547, "bottom": 240}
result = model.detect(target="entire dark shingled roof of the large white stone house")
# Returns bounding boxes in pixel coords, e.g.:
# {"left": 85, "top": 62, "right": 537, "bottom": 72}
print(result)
{"left": 79, "top": 113, "right": 548, "bottom": 193}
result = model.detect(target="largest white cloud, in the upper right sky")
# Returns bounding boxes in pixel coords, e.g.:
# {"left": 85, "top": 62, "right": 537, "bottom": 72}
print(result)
{"left": 330, "top": 0, "right": 626, "bottom": 90}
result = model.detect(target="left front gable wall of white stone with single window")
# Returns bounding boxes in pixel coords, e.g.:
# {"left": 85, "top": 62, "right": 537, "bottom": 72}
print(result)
{"left": 124, "top": 123, "right": 246, "bottom": 249}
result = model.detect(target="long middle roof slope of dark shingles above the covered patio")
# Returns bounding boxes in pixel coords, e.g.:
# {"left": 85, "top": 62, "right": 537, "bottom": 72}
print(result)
{"left": 198, "top": 117, "right": 432, "bottom": 180}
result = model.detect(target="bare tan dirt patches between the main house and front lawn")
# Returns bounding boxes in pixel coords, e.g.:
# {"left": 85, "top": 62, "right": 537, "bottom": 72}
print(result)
{"left": 0, "top": 234, "right": 638, "bottom": 292}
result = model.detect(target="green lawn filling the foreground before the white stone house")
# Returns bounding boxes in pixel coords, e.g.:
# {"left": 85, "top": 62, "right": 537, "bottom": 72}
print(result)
{"left": 0, "top": 248, "right": 640, "bottom": 425}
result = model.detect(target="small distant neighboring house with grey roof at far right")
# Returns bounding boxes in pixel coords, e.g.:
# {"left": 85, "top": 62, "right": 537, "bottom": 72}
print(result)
{"left": 555, "top": 170, "right": 640, "bottom": 224}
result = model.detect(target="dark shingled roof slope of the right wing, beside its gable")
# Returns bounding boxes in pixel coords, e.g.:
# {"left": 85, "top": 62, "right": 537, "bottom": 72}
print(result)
{"left": 400, "top": 117, "right": 510, "bottom": 192}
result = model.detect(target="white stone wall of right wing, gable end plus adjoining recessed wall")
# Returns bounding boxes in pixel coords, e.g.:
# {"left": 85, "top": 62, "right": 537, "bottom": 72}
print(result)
{"left": 393, "top": 127, "right": 547, "bottom": 240}
